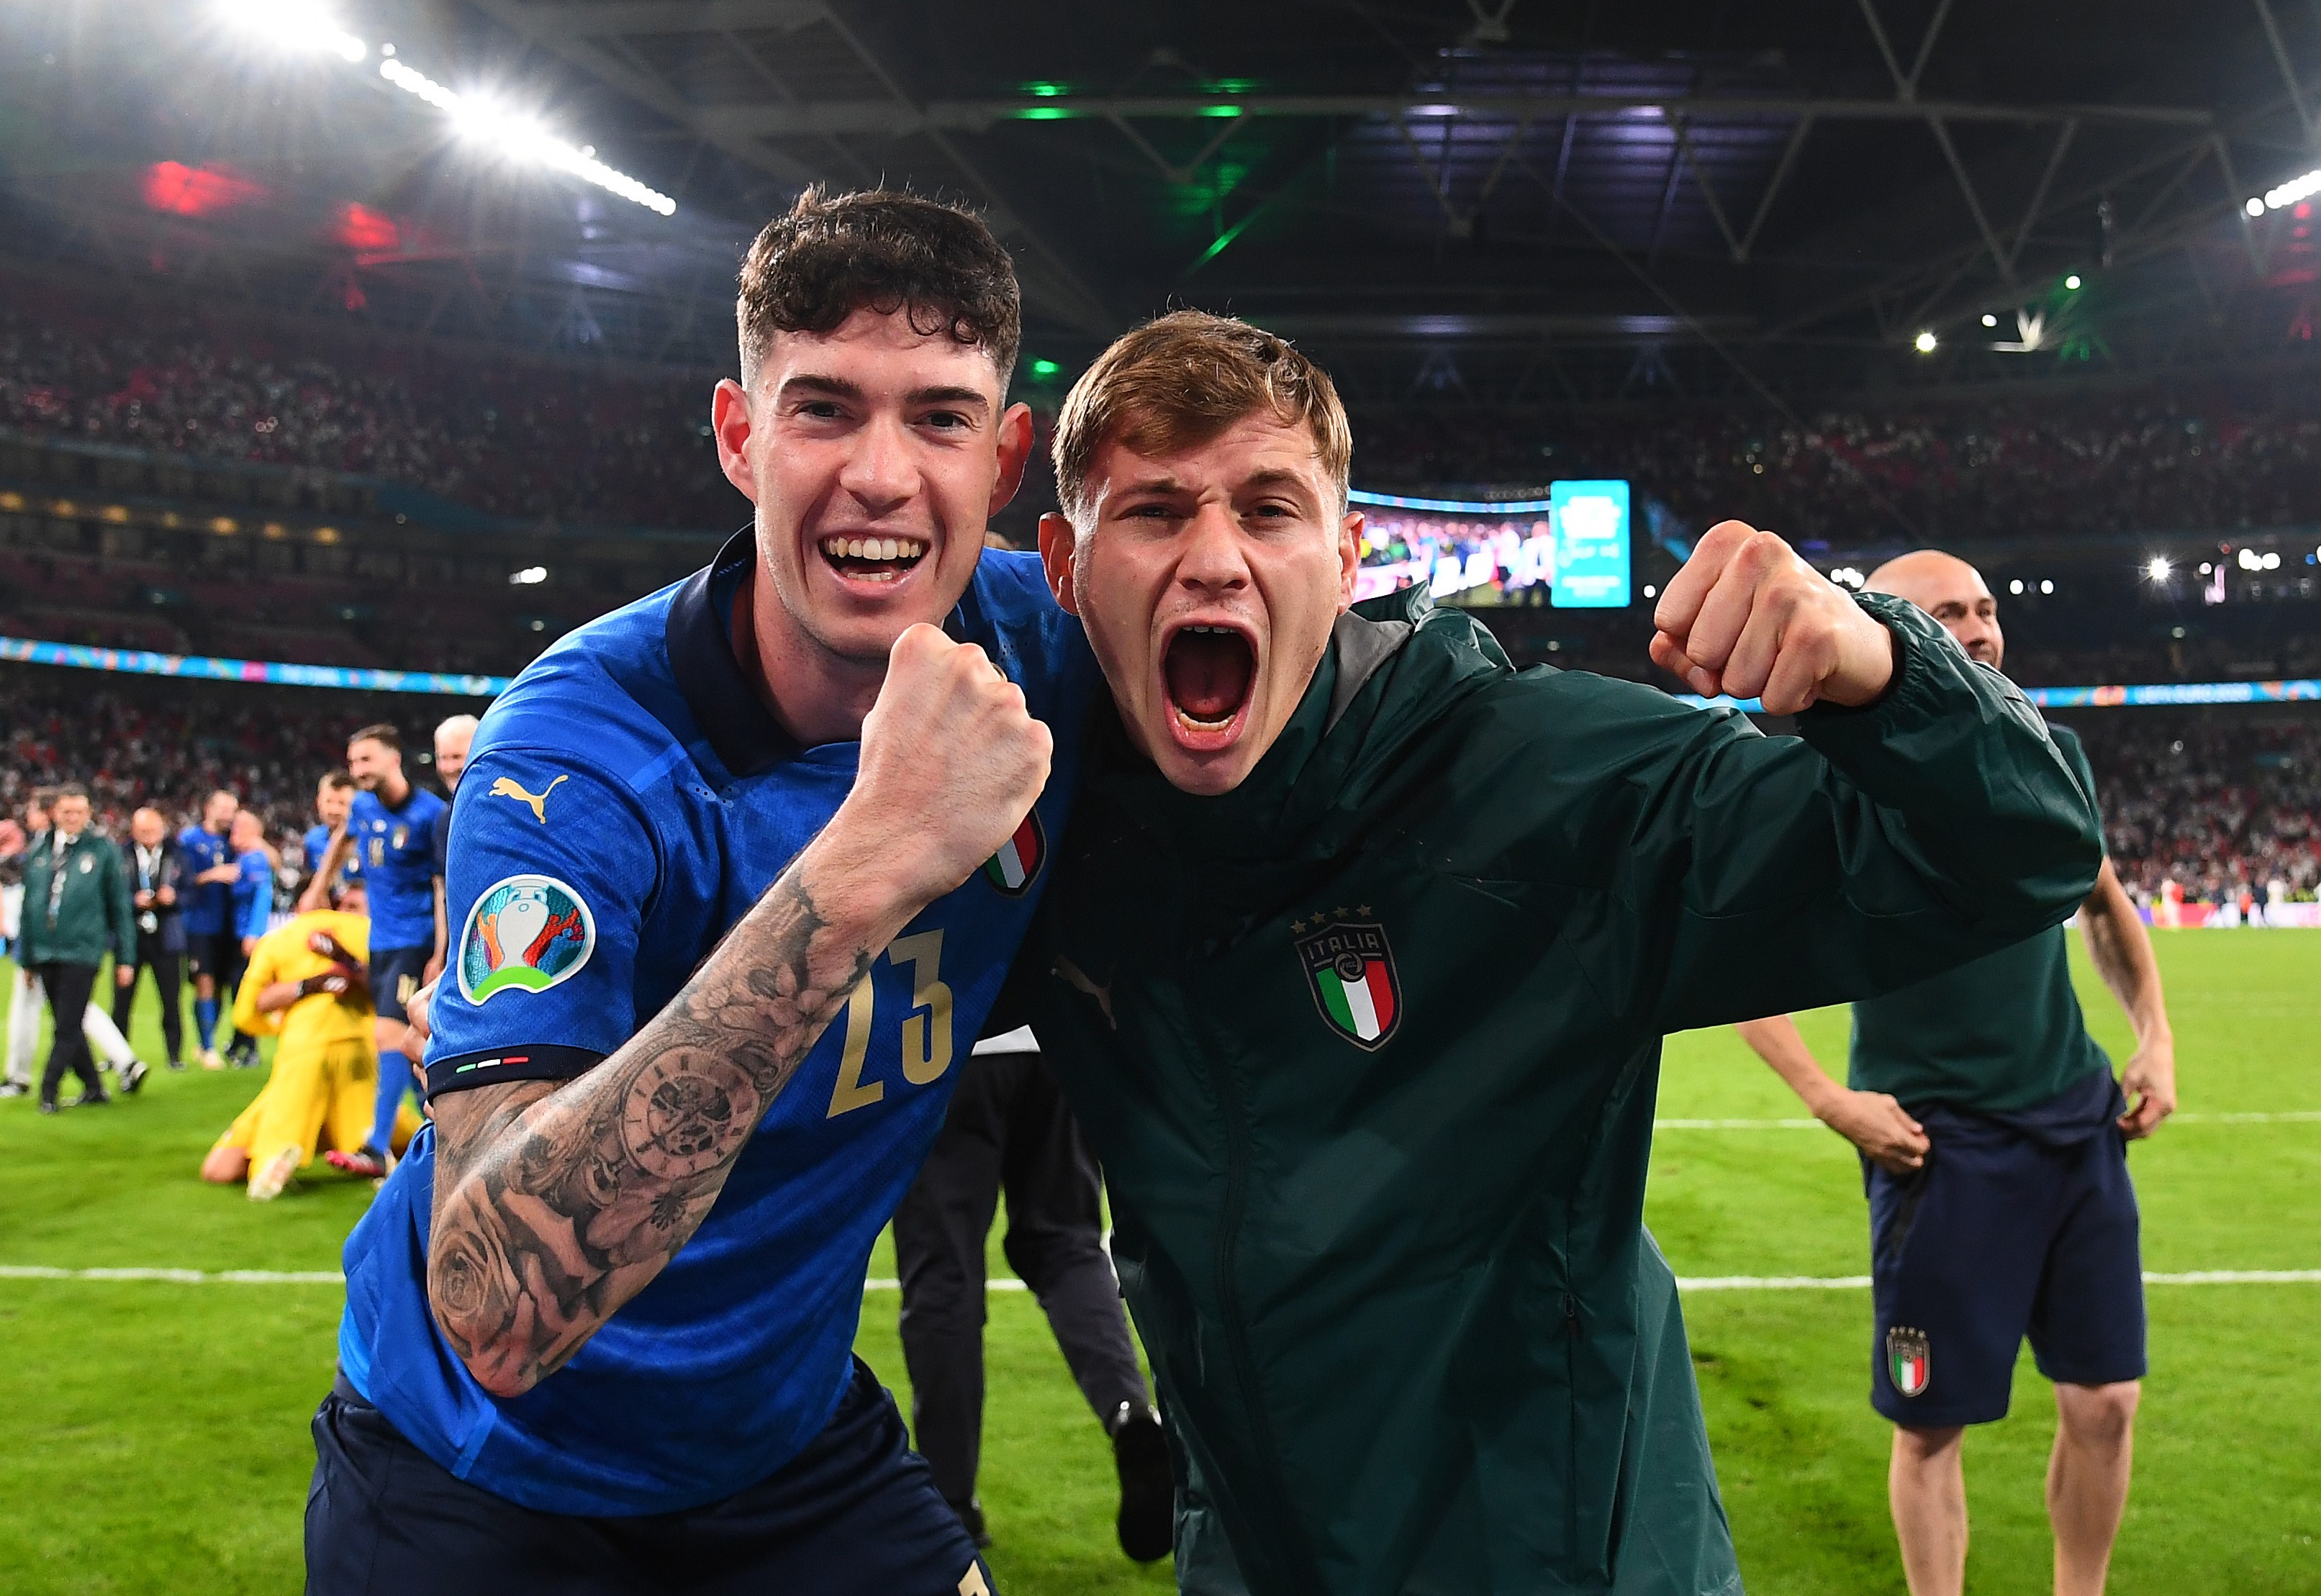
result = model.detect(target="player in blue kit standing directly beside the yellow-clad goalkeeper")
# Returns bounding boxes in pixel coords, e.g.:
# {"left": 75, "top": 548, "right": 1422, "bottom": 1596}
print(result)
{"left": 322, "top": 724, "right": 443, "bottom": 1179}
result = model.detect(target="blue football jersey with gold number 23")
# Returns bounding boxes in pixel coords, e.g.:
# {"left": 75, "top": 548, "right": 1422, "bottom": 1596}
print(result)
{"left": 339, "top": 531, "right": 1100, "bottom": 1515}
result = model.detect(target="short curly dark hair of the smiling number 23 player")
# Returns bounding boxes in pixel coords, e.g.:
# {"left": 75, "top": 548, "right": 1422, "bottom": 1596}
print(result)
{"left": 733, "top": 188, "right": 1023, "bottom": 392}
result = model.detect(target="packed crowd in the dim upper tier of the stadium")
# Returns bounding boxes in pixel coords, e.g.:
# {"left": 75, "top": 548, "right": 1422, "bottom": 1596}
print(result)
{"left": 13, "top": 271, "right": 2321, "bottom": 540}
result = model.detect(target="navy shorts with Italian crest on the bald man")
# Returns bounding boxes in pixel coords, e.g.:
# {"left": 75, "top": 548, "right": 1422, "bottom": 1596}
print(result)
{"left": 1861, "top": 1074, "right": 2145, "bottom": 1429}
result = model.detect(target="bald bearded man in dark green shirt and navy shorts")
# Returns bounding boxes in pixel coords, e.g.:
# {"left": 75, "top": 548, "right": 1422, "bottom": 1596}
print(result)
{"left": 1741, "top": 550, "right": 2175, "bottom": 1596}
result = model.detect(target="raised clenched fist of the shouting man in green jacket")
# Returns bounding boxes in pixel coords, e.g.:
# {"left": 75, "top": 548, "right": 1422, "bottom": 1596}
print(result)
{"left": 1652, "top": 522, "right": 1894, "bottom": 715}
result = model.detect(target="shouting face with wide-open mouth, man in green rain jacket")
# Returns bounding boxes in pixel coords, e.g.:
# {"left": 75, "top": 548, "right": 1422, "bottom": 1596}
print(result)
{"left": 1040, "top": 411, "right": 1362, "bottom": 794}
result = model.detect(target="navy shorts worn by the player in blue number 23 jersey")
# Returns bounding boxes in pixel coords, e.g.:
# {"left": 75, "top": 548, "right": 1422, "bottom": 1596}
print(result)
{"left": 307, "top": 1359, "right": 998, "bottom": 1596}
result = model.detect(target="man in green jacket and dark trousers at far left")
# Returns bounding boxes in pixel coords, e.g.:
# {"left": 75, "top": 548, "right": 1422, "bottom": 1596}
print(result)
{"left": 23, "top": 786, "right": 137, "bottom": 1113}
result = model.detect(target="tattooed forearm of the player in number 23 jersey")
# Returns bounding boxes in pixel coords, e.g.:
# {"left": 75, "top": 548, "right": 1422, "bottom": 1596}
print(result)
{"left": 427, "top": 856, "right": 882, "bottom": 1397}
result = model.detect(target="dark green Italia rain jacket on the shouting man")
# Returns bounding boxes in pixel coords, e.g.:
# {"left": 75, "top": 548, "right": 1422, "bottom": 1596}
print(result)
{"left": 1017, "top": 594, "right": 2103, "bottom": 1596}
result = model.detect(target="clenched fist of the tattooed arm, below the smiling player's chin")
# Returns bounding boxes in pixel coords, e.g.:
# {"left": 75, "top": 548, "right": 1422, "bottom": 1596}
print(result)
{"left": 833, "top": 624, "right": 1054, "bottom": 902}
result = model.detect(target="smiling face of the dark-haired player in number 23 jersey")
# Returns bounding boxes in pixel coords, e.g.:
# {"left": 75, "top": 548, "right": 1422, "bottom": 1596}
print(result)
{"left": 715, "top": 309, "right": 1031, "bottom": 675}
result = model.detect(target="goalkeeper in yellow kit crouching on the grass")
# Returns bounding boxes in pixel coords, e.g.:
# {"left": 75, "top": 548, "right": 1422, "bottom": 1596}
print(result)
{"left": 202, "top": 881, "right": 420, "bottom": 1202}
